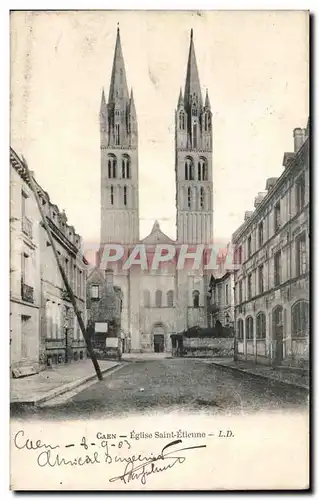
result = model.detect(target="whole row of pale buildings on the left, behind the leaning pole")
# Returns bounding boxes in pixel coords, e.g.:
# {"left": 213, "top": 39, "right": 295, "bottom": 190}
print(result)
{"left": 10, "top": 148, "right": 87, "bottom": 369}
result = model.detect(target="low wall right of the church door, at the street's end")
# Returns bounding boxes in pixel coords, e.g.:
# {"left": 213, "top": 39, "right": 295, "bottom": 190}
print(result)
{"left": 173, "top": 337, "right": 234, "bottom": 357}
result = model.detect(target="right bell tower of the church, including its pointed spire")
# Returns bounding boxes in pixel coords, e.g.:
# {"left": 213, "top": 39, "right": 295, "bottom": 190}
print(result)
{"left": 175, "top": 30, "right": 213, "bottom": 244}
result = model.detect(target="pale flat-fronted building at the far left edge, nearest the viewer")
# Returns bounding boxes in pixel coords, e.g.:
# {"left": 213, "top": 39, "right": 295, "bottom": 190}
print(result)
{"left": 10, "top": 149, "right": 41, "bottom": 374}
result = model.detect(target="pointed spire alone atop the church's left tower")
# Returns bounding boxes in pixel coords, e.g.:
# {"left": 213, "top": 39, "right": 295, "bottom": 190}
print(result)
{"left": 109, "top": 26, "right": 129, "bottom": 104}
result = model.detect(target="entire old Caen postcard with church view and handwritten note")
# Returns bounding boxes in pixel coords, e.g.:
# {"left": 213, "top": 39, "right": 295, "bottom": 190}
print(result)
{"left": 9, "top": 10, "right": 311, "bottom": 491}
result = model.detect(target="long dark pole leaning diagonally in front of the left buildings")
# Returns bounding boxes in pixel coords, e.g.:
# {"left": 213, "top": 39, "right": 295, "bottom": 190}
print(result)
{"left": 22, "top": 157, "right": 103, "bottom": 380}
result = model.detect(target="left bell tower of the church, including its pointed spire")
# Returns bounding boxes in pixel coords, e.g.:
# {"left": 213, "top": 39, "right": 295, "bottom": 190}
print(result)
{"left": 100, "top": 28, "right": 139, "bottom": 244}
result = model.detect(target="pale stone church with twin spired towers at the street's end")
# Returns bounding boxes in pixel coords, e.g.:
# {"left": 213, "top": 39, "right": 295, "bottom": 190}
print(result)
{"left": 100, "top": 28, "right": 213, "bottom": 352}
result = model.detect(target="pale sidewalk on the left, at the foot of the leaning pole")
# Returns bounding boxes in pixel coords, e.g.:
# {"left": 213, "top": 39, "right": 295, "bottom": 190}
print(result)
{"left": 10, "top": 359, "right": 119, "bottom": 405}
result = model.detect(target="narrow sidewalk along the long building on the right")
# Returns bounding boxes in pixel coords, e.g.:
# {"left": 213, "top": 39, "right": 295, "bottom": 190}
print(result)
{"left": 209, "top": 358, "right": 309, "bottom": 391}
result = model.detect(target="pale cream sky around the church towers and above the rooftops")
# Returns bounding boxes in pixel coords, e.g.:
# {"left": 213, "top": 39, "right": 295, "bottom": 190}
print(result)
{"left": 10, "top": 11, "right": 309, "bottom": 248}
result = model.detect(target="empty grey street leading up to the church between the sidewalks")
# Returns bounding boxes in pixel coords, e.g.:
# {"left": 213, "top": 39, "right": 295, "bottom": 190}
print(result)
{"left": 12, "top": 359, "right": 308, "bottom": 419}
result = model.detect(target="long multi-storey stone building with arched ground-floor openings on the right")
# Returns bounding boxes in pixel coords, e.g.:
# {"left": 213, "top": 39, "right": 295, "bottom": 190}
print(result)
{"left": 233, "top": 120, "right": 309, "bottom": 366}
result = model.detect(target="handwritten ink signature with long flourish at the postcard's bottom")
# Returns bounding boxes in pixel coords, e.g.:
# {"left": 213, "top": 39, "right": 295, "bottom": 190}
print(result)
{"left": 109, "top": 439, "right": 206, "bottom": 484}
